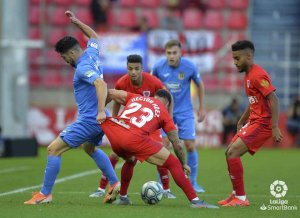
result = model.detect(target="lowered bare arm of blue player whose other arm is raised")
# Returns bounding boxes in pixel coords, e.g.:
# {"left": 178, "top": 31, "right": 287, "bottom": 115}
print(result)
{"left": 93, "top": 78, "right": 107, "bottom": 123}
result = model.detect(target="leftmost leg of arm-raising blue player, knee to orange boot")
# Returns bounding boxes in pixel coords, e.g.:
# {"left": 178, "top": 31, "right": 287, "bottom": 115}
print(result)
{"left": 24, "top": 137, "right": 70, "bottom": 204}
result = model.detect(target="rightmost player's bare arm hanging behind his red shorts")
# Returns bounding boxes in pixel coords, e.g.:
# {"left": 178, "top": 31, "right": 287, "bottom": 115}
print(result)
{"left": 267, "top": 92, "right": 282, "bottom": 142}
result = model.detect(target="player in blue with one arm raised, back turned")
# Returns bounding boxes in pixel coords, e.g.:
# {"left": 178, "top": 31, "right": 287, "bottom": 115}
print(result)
{"left": 24, "top": 11, "right": 120, "bottom": 204}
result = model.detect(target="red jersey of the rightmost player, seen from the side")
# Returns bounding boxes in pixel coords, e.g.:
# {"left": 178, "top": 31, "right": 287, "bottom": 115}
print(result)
{"left": 244, "top": 64, "right": 276, "bottom": 125}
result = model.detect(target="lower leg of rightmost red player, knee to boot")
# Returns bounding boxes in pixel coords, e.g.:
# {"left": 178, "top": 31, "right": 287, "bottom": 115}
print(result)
{"left": 218, "top": 137, "right": 250, "bottom": 207}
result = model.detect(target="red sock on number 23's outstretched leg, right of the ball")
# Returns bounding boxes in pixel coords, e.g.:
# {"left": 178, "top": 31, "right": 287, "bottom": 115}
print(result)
{"left": 162, "top": 154, "right": 197, "bottom": 201}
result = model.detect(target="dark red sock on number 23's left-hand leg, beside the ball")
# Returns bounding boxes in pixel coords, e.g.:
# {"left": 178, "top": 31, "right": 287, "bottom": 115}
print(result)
{"left": 120, "top": 160, "right": 137, "bottom": 196}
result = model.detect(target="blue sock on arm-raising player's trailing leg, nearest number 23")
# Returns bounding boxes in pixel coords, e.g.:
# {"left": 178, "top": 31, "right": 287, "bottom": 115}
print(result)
{"left": 91, "top": 149, "right": 119, "bottom": 185}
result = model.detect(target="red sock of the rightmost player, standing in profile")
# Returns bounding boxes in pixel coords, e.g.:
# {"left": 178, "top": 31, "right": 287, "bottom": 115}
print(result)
{"left": 226, "top": 157, "right": 245, "bottom": 196}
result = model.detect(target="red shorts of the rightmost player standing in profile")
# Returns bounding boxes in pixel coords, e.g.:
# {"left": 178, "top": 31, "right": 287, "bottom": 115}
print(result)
{"left": 231, "top": 122, "right": 272, "bottom": 155}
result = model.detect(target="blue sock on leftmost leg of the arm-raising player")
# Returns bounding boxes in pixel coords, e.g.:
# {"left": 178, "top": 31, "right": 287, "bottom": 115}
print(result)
{"left": 41, "top": 156, "right": 61, "bottom": 195}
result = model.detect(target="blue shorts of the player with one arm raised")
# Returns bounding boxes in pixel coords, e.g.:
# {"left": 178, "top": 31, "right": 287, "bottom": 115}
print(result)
{"left": 59, "top": 120, "right": 104, "bottom": 148}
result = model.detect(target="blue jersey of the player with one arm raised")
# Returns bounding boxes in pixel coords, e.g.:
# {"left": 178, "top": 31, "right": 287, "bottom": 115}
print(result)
{"left": 73, "top": 39, "right": 103, "bottom": 123}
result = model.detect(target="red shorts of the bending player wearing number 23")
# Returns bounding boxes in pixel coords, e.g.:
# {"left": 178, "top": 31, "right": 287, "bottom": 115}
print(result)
{"left": 101, "top": 119, "right": 163, "bottom": 162}
